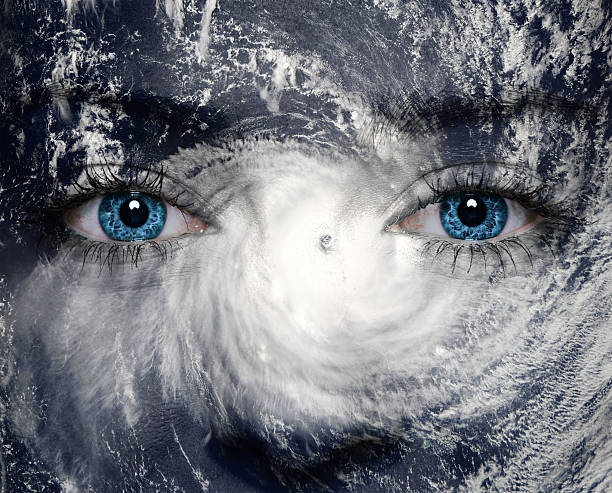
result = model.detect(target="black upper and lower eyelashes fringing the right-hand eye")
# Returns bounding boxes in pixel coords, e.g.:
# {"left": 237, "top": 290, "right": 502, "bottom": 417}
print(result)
{"left": 388, "top": 163, "right": 580, "bottom": 277}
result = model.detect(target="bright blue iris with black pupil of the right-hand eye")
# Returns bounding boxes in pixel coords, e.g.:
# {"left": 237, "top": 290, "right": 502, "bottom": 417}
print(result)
{"left": 440, "top": 193, "right": 508, "bottom": 240}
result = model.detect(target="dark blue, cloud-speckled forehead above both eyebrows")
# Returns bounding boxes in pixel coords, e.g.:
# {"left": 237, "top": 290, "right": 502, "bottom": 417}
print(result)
{"left": 4, "top": 0, "right": 609, "bottom": 106}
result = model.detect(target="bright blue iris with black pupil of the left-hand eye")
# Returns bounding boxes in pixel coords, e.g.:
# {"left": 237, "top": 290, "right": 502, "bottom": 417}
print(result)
{"left": 98, "top": 192, "right": 166, "bottom": 241}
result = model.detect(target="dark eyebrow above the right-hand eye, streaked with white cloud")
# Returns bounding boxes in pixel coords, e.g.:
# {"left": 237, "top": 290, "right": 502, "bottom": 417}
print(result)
{"left": 371, "top": 91, "right": 589, "bottom": 138}
